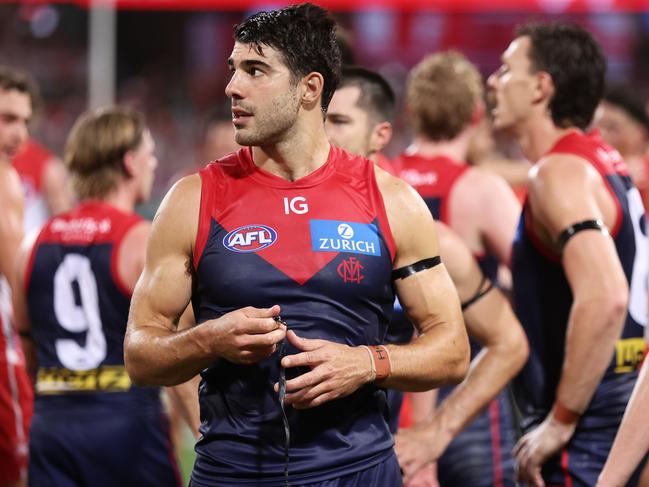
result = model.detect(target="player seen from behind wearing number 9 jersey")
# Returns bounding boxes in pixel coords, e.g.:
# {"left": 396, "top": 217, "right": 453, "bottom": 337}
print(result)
{"left": 16, "top": 108, "right": 194, "bottom": 487}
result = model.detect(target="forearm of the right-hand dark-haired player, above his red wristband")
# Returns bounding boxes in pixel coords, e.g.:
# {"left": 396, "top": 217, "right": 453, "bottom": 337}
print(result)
{"left": 557, "top": 298, "right": 627, "bottom": 413}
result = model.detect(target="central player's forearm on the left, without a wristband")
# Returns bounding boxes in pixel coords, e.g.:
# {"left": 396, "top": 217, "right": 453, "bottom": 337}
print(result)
{"left": 124, "top": 325, "right": 216, "bottom": 386}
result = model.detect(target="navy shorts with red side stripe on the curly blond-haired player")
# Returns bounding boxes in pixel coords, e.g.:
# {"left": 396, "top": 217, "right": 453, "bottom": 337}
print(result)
{"left": 437, "top": 390, "right": 516, "bottom": 487}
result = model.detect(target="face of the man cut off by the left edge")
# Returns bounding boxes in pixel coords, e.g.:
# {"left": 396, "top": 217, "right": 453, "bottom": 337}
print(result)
{"left": 0, "top": 88, "right": 32, "bottom": 160}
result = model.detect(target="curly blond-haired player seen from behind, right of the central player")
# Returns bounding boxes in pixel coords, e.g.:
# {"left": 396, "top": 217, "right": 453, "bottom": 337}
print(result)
{"left": 395, "top": 52, "right": 520, "bottom": 486}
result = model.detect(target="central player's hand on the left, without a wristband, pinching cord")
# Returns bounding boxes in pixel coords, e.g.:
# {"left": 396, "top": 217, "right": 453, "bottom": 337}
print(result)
{"left": 210, "top": 305, "right": 286, "bottom": 364}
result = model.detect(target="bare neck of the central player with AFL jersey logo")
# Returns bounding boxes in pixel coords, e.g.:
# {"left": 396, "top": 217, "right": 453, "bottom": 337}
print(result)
{"left": 252, "top": 115, "right": 330, "bottom": 181}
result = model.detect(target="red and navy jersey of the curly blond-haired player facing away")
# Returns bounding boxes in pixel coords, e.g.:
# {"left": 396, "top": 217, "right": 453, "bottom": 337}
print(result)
{"left": 395, "top": 154, "right": 498, "bottom": 282}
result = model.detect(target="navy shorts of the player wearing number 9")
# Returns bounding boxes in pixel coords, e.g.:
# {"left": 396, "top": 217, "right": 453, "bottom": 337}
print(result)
{"left": 29, "top": 411, "right": 182, "bottom": 487}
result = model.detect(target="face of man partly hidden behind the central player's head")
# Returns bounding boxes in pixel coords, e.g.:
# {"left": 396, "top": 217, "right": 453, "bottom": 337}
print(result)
{"left": 325, "top": 86, "right": 372, "bottom": 157}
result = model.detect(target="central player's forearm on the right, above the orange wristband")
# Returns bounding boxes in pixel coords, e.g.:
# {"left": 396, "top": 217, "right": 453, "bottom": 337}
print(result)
{"left": 382, "top": 321, "right": 469, "bottom": 391}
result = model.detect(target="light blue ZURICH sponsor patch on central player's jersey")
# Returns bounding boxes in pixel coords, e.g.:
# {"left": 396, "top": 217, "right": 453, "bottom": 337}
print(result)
{"left": 310, "top": 220, "right": 381, "bottom": 257}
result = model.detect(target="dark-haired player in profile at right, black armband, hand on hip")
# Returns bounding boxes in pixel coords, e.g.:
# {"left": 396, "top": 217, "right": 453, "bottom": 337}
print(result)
{"left": 489, "top": 24, "right": 649, "bottom": 487}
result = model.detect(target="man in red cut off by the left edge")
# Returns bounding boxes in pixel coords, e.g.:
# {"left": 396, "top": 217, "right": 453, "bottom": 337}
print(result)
{"left": 0, "top": 67, "right": 34, "bottom": 487}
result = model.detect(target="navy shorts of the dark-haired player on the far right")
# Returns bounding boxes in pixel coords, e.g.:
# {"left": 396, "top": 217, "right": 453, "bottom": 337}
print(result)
{"left": 541, "top": 427, "right": 646, "bottom": 487}
